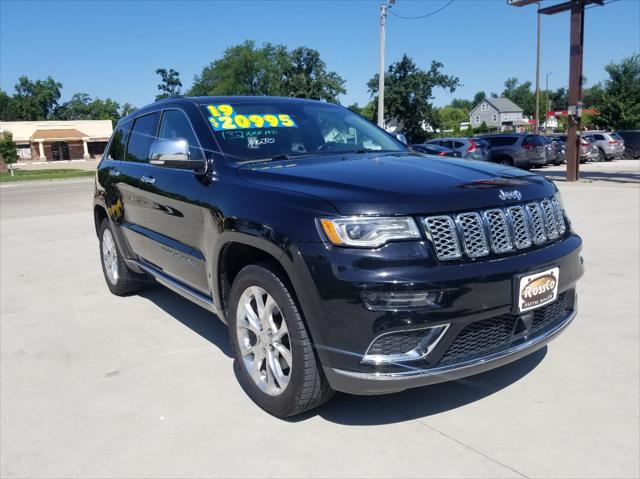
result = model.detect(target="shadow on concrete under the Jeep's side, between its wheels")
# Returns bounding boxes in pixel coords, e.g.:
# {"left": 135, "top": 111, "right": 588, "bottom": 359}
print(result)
{"left": 139, "top": 284, "right": 233, "bottom": 358}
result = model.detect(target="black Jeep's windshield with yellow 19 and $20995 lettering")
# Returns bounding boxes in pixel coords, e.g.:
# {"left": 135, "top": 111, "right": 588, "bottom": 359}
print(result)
{"left": 202, "top": 100, "right": 407, "bottom": 161}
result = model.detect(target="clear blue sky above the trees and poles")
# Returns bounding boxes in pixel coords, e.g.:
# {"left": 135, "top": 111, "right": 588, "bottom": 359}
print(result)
{"left": 0, "top": 0, "right": 640, "bottom": 106}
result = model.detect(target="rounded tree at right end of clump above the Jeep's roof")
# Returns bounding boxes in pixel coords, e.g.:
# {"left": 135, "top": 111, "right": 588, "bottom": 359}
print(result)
{"left": 282, "top": 47, "right": 347, "bottom": 103}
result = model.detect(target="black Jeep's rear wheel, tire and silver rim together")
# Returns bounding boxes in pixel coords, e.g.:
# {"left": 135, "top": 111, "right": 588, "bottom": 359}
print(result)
{"left": 100, "top": 219, "right": 147, "bottom": 296}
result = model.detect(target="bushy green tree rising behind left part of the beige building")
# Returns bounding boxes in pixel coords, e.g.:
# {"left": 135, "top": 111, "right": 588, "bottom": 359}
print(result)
{"left": 12, "top": 76, "right": 62, "bottom": 120}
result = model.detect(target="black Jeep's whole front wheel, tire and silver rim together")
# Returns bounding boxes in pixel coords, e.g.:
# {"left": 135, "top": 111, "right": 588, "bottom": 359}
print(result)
{"left": 228, "top": 263, "right": 334, "bottom": 417}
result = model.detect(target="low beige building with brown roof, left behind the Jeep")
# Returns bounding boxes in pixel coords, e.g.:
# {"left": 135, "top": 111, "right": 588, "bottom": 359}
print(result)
{"left": 0, "top": 120, "right": 113, "bottom": 161}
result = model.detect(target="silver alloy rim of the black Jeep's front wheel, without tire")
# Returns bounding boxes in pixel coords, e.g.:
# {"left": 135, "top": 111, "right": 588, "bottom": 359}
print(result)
{"left": 236, "top": 286, "right": 293, "bottom": 396}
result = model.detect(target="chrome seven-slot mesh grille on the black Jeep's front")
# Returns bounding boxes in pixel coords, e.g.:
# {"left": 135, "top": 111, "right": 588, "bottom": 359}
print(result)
{"left": 422, "top": 198, "right": 567, "bottom": 261}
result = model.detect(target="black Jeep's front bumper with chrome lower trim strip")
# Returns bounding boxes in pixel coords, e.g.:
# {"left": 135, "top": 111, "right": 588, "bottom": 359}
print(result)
{"left": 300, "top": 233, "right": 583, "bottom": 394}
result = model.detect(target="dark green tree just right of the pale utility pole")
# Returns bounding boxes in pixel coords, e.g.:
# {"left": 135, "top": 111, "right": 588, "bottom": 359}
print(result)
{"left": 367, "top": 54, "right": 460, "bottom": 143}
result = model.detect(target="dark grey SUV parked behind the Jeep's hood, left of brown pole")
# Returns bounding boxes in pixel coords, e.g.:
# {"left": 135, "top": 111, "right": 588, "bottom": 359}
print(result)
{"left": 479, "top": 133, "right": 547, "bottom": 170}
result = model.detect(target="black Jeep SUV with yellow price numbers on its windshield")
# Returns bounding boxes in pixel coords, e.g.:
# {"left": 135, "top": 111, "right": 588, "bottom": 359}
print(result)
{"left": 94, "top": 97, "right": 583, "bottom": 416}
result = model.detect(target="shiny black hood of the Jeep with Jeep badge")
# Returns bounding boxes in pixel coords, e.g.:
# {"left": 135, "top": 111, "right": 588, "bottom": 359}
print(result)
{"left": 238, "top": 153, "right": 556, "bottom": 215}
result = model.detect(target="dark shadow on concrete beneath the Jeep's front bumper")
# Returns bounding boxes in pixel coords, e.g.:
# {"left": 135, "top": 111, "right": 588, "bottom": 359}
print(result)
{"left": 300, "top": 346, "right": 547, "bottom": 426}
